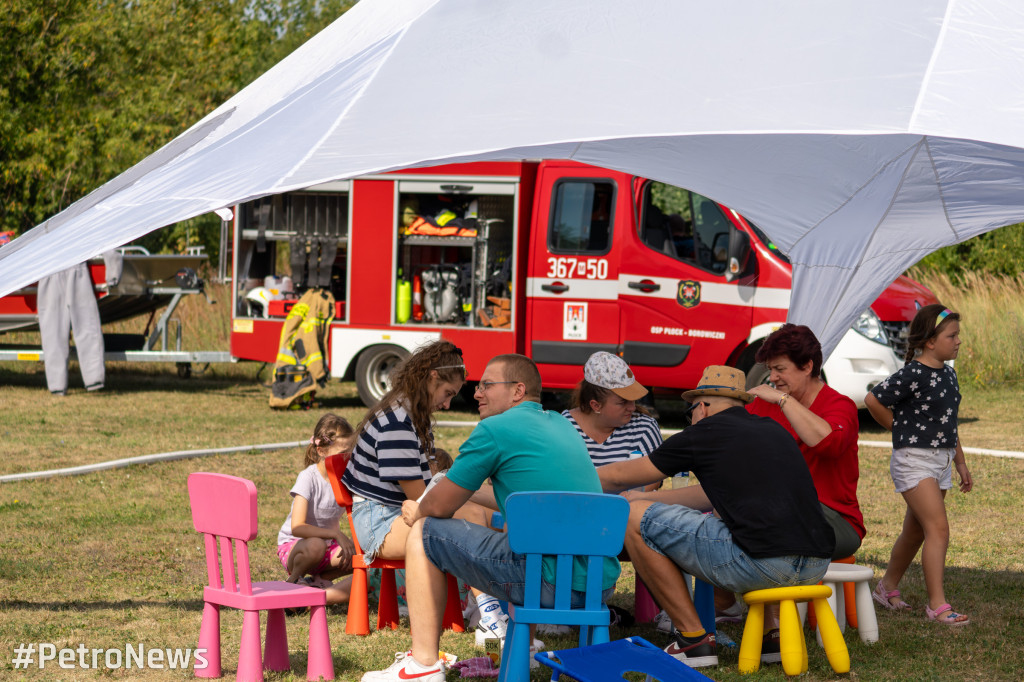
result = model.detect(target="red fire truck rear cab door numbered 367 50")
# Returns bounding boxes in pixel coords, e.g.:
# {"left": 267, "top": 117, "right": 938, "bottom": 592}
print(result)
{"left": 526, "top": 167, "right": 629, "bottom": 388}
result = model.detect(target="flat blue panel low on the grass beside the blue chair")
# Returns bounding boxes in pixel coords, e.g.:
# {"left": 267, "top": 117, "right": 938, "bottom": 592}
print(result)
{"left": 534, "top": 637, "right": 711, "bottom": 682}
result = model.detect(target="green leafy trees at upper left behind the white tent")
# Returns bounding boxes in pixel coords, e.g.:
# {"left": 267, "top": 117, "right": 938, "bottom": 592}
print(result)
{"left": 0, "top": 0, "right": 348, "bottom": 260}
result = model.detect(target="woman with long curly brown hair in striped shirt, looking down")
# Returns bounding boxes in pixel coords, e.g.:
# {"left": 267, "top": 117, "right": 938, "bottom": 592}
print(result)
{"left": 342, "top": 341, "right": 466, "bottom": 561}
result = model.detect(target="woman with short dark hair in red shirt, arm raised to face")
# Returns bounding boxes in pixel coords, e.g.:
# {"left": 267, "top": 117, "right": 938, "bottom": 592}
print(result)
{"left": 746, "top": 324, "right": 864, "bottom": 559}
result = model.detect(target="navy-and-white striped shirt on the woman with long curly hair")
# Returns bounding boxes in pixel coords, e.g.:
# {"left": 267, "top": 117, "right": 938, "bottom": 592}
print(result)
{"left": 341, "top": 404, "right": 430, "bottom": 507}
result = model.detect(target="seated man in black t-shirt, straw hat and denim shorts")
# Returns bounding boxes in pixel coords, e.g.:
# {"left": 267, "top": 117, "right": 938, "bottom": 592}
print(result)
{"left": 598, "top": 366, "right": 836, "bottom": 668}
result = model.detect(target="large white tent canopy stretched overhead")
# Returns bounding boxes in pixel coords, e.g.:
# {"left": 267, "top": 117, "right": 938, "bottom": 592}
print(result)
{"left": 0, "top": 0, "right": 1024, "bottom": 354}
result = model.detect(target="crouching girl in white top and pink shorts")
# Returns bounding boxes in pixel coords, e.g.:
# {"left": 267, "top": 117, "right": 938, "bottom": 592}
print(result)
{"left": 278, "top": 414, "right": 355, "bottom": 604}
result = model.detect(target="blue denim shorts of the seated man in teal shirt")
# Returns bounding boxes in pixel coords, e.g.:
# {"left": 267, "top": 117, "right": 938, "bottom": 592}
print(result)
{"left": 423, "top": 518, "right": 615, "bottom": 608}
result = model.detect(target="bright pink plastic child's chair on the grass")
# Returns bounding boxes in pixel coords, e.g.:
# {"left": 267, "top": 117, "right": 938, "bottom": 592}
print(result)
{"left": 188, "top": 473, "right": 334, "bottom": 682}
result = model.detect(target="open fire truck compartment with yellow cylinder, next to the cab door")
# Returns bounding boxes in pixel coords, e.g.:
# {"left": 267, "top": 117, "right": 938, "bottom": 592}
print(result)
{"left": 393, "top": 178, "right": 517, "bottom": 329}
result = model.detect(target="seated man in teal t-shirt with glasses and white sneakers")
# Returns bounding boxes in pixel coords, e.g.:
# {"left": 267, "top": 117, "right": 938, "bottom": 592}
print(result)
{"left": 362, "top": 354, "right": 620, "bottom": 682}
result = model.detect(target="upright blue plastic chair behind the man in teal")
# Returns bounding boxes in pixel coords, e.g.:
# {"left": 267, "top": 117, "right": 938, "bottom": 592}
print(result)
{"left": 498, "top": 493, "right": 630, "bottom": 682}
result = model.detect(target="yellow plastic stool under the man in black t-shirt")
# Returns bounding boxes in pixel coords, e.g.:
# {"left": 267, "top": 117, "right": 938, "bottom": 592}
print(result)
{"left": 739, "top": 585, "right": 850, "bottom": 675}
